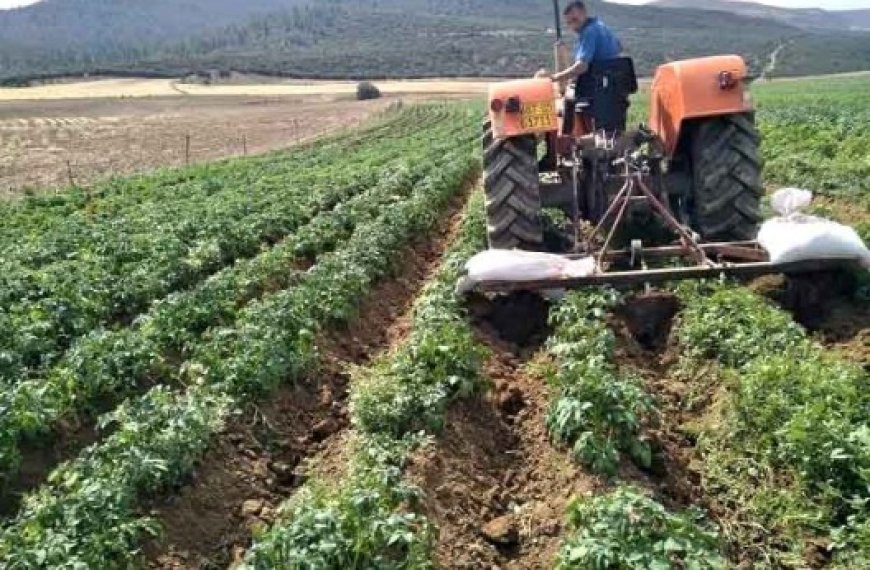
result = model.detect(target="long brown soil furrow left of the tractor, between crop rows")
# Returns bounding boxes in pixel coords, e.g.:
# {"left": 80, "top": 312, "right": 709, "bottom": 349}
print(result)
{"left": 145, "top": 185, "right": 471, "bottom": 569}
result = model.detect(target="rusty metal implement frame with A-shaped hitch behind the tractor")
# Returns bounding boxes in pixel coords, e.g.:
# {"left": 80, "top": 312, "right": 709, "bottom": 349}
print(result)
{"left": 477, "top": 152, "right": 857, "bottom": 293}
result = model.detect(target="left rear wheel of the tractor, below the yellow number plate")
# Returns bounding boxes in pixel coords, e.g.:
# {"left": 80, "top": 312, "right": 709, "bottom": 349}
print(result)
{"left": 483, "top": 121, "right": 544, "bottom": 251}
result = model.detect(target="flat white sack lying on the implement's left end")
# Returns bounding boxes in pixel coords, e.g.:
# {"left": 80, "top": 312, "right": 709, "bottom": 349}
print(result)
{"left": 457, "top": 249, "right": 595, "bottom": 293}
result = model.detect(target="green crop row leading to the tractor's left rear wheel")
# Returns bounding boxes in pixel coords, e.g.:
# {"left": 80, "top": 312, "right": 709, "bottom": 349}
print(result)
{"left": 245, "top": 194, "right": 494, "bottom": 570}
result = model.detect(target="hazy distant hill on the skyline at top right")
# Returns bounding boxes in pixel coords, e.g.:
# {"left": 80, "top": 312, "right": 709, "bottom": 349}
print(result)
{"left": 653, "top": 0, "right": 870, "bottom": 31}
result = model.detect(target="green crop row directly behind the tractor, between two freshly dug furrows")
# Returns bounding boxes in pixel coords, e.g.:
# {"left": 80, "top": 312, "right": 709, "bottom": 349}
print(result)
{"left": 547, "top": 290, "right": 725, "bottom": 570}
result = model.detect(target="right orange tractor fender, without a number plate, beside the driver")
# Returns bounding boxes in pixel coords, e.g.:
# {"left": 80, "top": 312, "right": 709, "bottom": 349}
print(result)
{"left": 650, "top": 55, "right": 754, "bottom": 156}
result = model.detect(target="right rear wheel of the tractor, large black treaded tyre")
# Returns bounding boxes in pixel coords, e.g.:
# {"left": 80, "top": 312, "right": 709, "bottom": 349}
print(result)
{"left": 689, "top": 113, "right": 762, "bottom": 241}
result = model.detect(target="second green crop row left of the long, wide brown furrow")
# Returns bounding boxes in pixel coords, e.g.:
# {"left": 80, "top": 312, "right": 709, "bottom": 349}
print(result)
{"left": 0, "top": 124, "right": 470, "bottom": 480}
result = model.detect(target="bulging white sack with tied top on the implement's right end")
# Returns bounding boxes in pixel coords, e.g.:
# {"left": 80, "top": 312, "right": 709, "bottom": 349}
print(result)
{"left": 758, "top": 188, "right": 870, "bottom": 268}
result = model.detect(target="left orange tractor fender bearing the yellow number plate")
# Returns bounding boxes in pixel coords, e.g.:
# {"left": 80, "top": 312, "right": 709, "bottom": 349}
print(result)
{"left": 487, "top": 78, "right": 559, "bottom": 139}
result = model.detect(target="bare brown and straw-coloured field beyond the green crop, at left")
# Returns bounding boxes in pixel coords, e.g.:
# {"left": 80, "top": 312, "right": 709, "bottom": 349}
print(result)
{"left": 0, "top": 76, "right": 486, "bottom": 195}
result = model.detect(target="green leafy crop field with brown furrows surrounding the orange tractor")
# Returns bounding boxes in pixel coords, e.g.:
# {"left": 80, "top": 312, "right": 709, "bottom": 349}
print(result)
{"left": 0, "top": 73, "right": 870, "bottom": 570}
